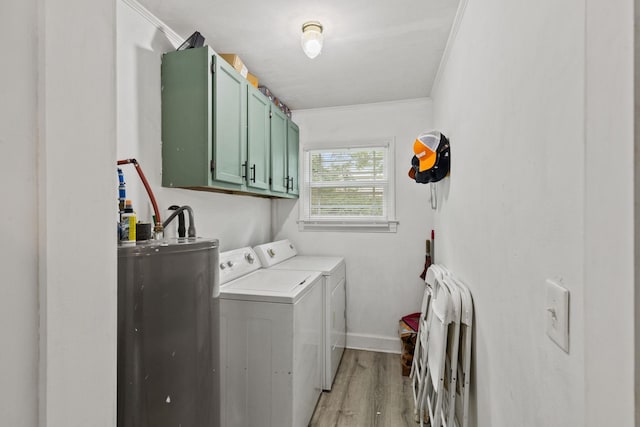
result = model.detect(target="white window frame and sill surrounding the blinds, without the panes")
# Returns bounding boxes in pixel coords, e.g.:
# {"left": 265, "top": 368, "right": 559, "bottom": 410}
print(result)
{"left": 298, "top": 137, "right": 398, "bottom": 233}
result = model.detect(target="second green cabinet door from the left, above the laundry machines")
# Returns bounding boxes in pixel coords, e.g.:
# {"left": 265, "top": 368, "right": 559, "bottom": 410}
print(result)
{"left": 246, "top": 85, "right": 271, "bottom": 190}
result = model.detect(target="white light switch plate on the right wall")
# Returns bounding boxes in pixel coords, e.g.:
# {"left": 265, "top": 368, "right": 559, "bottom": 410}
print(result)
{"left": 545, "top": 279, "right": 569, "bottom": 353}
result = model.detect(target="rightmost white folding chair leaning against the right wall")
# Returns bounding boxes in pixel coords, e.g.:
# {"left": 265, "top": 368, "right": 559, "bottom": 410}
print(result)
{"left": 450, "top": 277, "right": 473, "bottom": 427}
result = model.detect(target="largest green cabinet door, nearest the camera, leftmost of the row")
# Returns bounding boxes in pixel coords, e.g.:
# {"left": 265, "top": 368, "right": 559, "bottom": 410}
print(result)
{"left": 212, "top": 56, "right": 247, "bottom": 184}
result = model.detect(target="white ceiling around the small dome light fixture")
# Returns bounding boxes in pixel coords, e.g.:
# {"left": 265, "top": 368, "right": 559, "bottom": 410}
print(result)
{"left": 140, "top": 0, "right": 458, "bottom": 109}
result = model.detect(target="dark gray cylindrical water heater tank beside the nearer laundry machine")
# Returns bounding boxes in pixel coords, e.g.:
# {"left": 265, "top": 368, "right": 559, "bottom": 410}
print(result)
{"left": 118, "top": 239, "right": 220, "bottom": 427}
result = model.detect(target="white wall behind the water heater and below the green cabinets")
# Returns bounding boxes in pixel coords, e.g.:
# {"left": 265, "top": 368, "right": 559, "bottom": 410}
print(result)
{"left": 113, "top": 0, "right": 271, "bottom": 250}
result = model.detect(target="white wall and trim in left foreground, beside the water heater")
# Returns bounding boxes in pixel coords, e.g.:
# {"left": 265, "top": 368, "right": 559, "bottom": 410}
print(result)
{"left": 0, "top": 0, "right": 116, "bottom": 427}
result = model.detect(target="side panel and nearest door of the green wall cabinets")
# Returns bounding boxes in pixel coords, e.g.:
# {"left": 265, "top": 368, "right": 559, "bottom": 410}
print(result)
{"left": 162, "top": 47, "right": 247, "bottom": 190}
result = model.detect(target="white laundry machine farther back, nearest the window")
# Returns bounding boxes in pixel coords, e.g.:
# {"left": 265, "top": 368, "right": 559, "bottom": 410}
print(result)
{"left": 254, "top": 239, "right": 347, "bottom": 390}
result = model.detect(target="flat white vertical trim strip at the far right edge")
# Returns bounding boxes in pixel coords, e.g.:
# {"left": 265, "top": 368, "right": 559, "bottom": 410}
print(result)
{"left": 584, "top": 0, "right": 638, "bottom": 427}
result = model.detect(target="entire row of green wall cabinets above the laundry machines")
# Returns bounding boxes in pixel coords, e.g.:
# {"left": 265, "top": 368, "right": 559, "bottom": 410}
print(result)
{"left": 162, "top": 46, "right": 298, "bottom": 197}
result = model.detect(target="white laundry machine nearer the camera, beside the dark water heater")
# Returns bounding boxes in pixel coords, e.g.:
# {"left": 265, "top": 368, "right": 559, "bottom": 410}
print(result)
{"left": 219, "top": 248, "right": 322, "bottom": 427}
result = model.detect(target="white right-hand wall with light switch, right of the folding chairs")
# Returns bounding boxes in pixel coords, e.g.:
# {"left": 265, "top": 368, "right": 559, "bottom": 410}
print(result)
{"left": 433, "top": 0, "right": 633, "bottom": 427}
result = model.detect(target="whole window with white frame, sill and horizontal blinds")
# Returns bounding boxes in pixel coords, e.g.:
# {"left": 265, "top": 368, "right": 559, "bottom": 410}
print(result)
{"left": 299, "top": 140, "right": 397, "bottom": 232}
